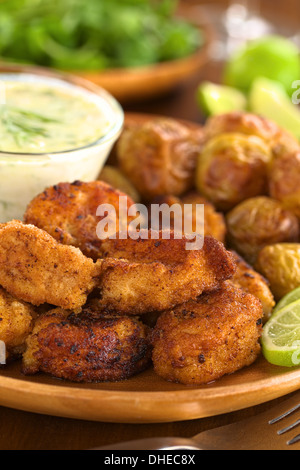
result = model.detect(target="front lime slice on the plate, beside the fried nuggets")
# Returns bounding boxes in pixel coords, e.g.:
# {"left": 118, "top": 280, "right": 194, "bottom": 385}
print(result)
{"left": 261, "top": 300, "right": 300, "bottom": 367}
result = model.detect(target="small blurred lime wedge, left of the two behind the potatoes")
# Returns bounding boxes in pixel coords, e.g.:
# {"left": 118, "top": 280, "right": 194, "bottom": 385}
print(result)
{"left": 197, "top": 82, "right": 247, "bottom": 115}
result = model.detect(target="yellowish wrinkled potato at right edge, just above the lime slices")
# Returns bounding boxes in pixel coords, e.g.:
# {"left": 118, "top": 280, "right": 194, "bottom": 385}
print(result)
{"left": 256, "top": 243, "right": 300, "bottom": 301}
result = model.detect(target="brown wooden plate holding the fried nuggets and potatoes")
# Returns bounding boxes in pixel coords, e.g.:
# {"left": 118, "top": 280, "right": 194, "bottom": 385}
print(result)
{"left": 0, "top": 114, "right": 300, "bottom": 423}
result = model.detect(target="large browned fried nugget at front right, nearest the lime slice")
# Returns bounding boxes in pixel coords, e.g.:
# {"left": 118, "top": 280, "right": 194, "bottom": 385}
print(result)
{"left": 152, "top": 285, "right": 263, "bottom": 385}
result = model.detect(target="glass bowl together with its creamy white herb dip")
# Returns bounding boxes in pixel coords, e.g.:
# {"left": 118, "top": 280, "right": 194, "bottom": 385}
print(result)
{"left": 0, "top": 72, "right": 124, "bottom": 223}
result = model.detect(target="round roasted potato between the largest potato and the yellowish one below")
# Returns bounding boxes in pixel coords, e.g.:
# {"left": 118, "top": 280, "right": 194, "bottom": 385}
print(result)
{"left": 226, "top": 196, "right": 300, "bottom": 264}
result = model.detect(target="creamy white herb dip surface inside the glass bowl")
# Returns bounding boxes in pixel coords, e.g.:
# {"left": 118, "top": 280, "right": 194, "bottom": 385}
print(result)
{"left": 0, "top": 75, "right": 111, "bottom": 153}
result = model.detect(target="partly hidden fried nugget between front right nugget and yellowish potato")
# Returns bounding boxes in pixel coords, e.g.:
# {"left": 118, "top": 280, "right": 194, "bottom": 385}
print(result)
{"left": 226, "top": 252, "right": 275, "bottom": 322}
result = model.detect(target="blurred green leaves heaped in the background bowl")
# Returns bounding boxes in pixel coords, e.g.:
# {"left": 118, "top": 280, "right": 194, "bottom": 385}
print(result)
{"left": 0, "top": 0, "right": 203, "bottom": 70}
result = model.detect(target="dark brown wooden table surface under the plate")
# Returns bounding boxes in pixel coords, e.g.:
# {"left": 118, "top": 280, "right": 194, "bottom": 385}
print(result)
{"left": 0, "top": 0, "right": 300, "bottom": 450}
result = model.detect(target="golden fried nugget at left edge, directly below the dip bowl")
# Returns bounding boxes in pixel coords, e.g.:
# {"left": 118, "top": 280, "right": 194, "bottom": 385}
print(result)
{"left": 0, "top": 221, "right": 101, "bottom": 310}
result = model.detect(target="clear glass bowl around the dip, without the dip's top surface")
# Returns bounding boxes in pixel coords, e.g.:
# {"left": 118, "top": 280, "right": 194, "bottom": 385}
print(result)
{"left": 0, "top": 65, "right": 124, "bottom": 223}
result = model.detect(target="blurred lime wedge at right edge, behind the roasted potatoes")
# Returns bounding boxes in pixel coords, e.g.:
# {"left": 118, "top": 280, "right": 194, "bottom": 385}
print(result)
{"left": 249, "top": 78, "right": 300, "bottom": 139}
